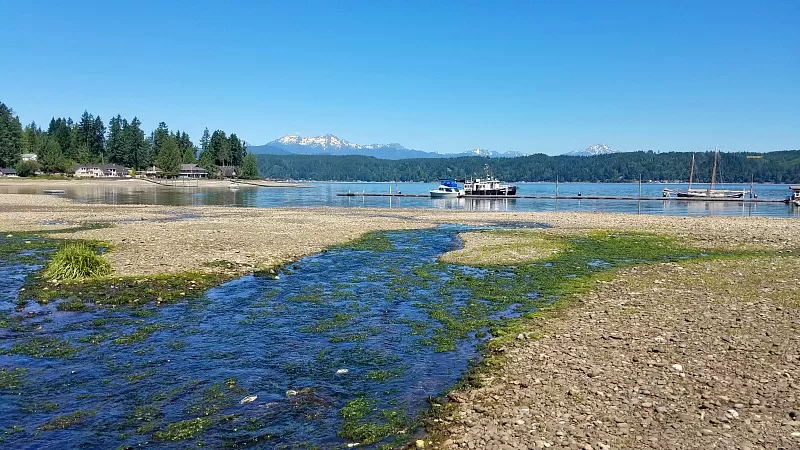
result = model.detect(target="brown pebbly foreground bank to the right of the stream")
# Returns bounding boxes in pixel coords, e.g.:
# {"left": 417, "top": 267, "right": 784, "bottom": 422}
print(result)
{"left": 434, "top": 257, "right": 800, "bottom": 450}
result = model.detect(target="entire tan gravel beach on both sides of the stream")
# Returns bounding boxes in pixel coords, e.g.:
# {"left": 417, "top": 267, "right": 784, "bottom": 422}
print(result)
{"left": 0, "top": 194, "right": 800, "bottom": 450}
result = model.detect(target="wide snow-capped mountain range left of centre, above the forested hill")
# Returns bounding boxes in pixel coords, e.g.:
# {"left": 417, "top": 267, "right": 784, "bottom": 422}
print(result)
{"left": 247, "top": 134, "right": 524, "bottom": 159}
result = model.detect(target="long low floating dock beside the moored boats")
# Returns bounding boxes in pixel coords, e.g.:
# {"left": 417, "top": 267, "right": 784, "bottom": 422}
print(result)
{"left": 336, "top": 192, "right": 786, "bottom": 203}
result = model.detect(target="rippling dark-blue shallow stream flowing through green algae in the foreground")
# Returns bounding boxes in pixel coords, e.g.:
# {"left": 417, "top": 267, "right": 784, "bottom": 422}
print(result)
{"left": 0, "top": 227, "right": 532, "bottom": 448}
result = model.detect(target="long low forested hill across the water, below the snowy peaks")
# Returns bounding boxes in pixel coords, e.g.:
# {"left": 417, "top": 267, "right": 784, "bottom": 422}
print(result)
{"left": 258, "top": 150, "right": 800, "bottom": 183}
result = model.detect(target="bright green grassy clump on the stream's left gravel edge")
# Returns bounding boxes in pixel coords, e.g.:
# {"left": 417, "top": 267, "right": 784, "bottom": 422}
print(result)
{"left": 44, "top": 242, "right": 112, "bottom": 281}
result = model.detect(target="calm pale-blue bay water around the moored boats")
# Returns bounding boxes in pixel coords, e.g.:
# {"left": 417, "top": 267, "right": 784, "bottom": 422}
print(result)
{"left": 0, "top": 181, "right": 800, "bottom": 217}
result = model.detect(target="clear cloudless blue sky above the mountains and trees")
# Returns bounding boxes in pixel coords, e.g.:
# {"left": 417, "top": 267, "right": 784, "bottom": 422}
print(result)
{"left": 0, "top": 0, "right": 800, "bottom": 154}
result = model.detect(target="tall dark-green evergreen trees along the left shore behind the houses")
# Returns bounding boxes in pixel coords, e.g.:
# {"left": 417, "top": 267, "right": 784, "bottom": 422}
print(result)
{"left": 0, "top": 102, "right": 259, "bottom": 178}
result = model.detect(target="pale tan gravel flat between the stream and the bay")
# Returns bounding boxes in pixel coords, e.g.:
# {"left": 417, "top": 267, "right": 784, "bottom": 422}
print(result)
{"left": 0, "top": 194, "right": 800, "bottom": 275}
